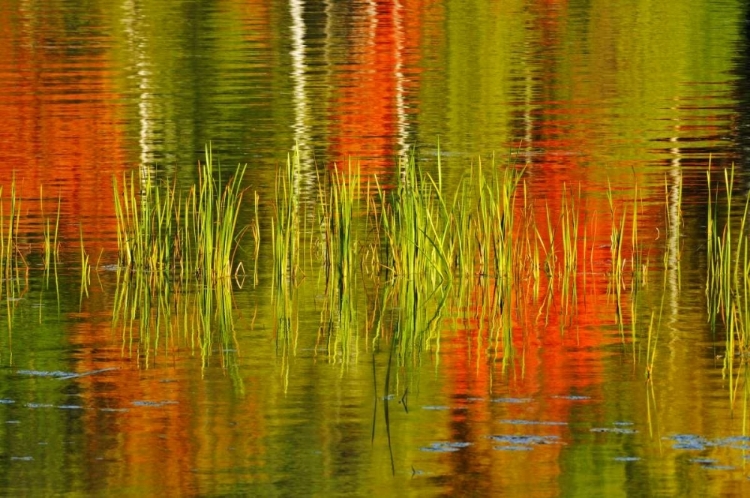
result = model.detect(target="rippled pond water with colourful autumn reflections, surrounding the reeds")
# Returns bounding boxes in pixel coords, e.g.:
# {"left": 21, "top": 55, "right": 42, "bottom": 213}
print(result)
{"left": 0, "top": 0, "right": 750, "bottom": 496}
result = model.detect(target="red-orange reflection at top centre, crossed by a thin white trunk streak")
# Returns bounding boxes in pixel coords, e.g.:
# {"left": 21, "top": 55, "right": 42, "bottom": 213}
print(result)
{"left": 330, "top": 0, "right": 426, "bottom": 172}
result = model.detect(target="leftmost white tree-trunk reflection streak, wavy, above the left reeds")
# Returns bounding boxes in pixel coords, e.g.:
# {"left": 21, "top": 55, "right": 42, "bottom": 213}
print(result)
{"left": 122, "top": 0, "right": 156, "bottom": 182}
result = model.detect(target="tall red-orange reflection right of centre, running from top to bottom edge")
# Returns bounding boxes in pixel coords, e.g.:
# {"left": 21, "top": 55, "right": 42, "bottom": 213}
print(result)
{"left": 440, "top": 1, "right": 665, "bottom": 495}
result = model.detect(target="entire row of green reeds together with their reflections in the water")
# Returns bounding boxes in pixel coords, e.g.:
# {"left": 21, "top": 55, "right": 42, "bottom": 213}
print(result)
{"left": 0, "top": 147, "right": 750, "bottom": 416}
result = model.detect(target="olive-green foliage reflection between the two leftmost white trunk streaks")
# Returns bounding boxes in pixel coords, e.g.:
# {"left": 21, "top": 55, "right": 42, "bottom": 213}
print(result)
{"left": 113, "top": 1, "right": 288, "bottom": 177}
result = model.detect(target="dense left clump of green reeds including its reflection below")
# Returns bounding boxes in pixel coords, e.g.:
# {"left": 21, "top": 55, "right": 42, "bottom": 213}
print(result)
{"left": 107, "top": 146, "right": 248, "bottom": 382}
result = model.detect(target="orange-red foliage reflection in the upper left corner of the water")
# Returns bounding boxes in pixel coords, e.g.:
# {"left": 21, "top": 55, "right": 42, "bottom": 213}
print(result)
{"left": 0, "top": 3, "right": 127, "bottom": 260}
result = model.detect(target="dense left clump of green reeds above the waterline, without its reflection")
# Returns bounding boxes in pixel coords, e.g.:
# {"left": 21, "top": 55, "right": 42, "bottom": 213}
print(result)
{"left": 113, "top": 146, "right": 246, "bottom": 283}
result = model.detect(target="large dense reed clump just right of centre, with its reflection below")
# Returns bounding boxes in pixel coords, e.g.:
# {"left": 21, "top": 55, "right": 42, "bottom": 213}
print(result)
{"left": 370, "top": 154, "right": 523, "bottom": 372}
